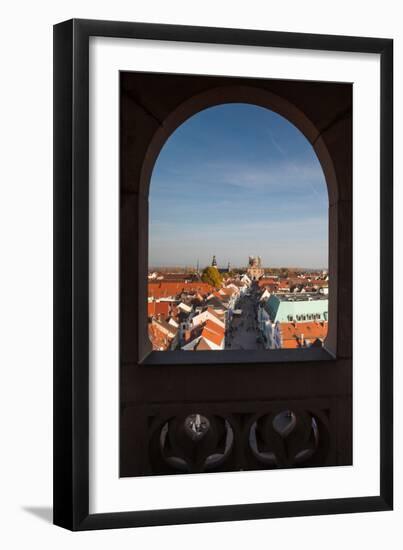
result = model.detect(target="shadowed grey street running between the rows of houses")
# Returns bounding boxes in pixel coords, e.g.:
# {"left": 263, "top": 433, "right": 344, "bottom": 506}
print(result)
{"left": 225, "top": 288, "right": 264, "bottom": 350}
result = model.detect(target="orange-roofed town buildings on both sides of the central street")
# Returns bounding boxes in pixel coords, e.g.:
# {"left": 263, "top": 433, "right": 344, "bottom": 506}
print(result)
{"left": 148, "top": 273, "right": 328, "bottom": 351}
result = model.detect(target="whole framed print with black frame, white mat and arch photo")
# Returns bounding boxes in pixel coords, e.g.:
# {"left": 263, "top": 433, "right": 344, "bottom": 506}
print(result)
{"left": 54, "top": 20, "right": 393, "bottom": 530}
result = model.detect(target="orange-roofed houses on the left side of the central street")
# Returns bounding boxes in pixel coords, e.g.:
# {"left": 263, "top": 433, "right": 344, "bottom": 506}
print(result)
{"left": 147, "top": 277, "right": 251, "bottom": 351}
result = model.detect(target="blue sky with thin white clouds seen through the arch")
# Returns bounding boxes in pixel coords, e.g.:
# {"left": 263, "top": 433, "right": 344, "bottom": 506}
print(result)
{"left": 149, "top": 103, "right": 328, "bottom": 268}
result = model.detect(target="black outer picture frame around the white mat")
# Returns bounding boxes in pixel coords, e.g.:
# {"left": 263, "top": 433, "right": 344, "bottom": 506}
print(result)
{"left": 54, "top": 19, "right": 393, "bottom": 531}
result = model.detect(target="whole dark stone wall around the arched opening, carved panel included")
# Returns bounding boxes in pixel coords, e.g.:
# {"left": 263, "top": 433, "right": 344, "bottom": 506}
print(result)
{"left": 120, "top": 73, "right": 352, "bottom": 477}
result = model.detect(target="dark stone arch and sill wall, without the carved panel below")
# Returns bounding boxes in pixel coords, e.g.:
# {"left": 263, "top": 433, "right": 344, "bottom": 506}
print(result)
{"left": 119, "top": 72, "right": 352, "bottom": 477}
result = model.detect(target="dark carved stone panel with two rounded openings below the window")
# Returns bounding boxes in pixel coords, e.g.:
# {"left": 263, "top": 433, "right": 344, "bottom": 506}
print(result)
{"left": 148, "top": 407, "right": 334, "bottom": 474}
